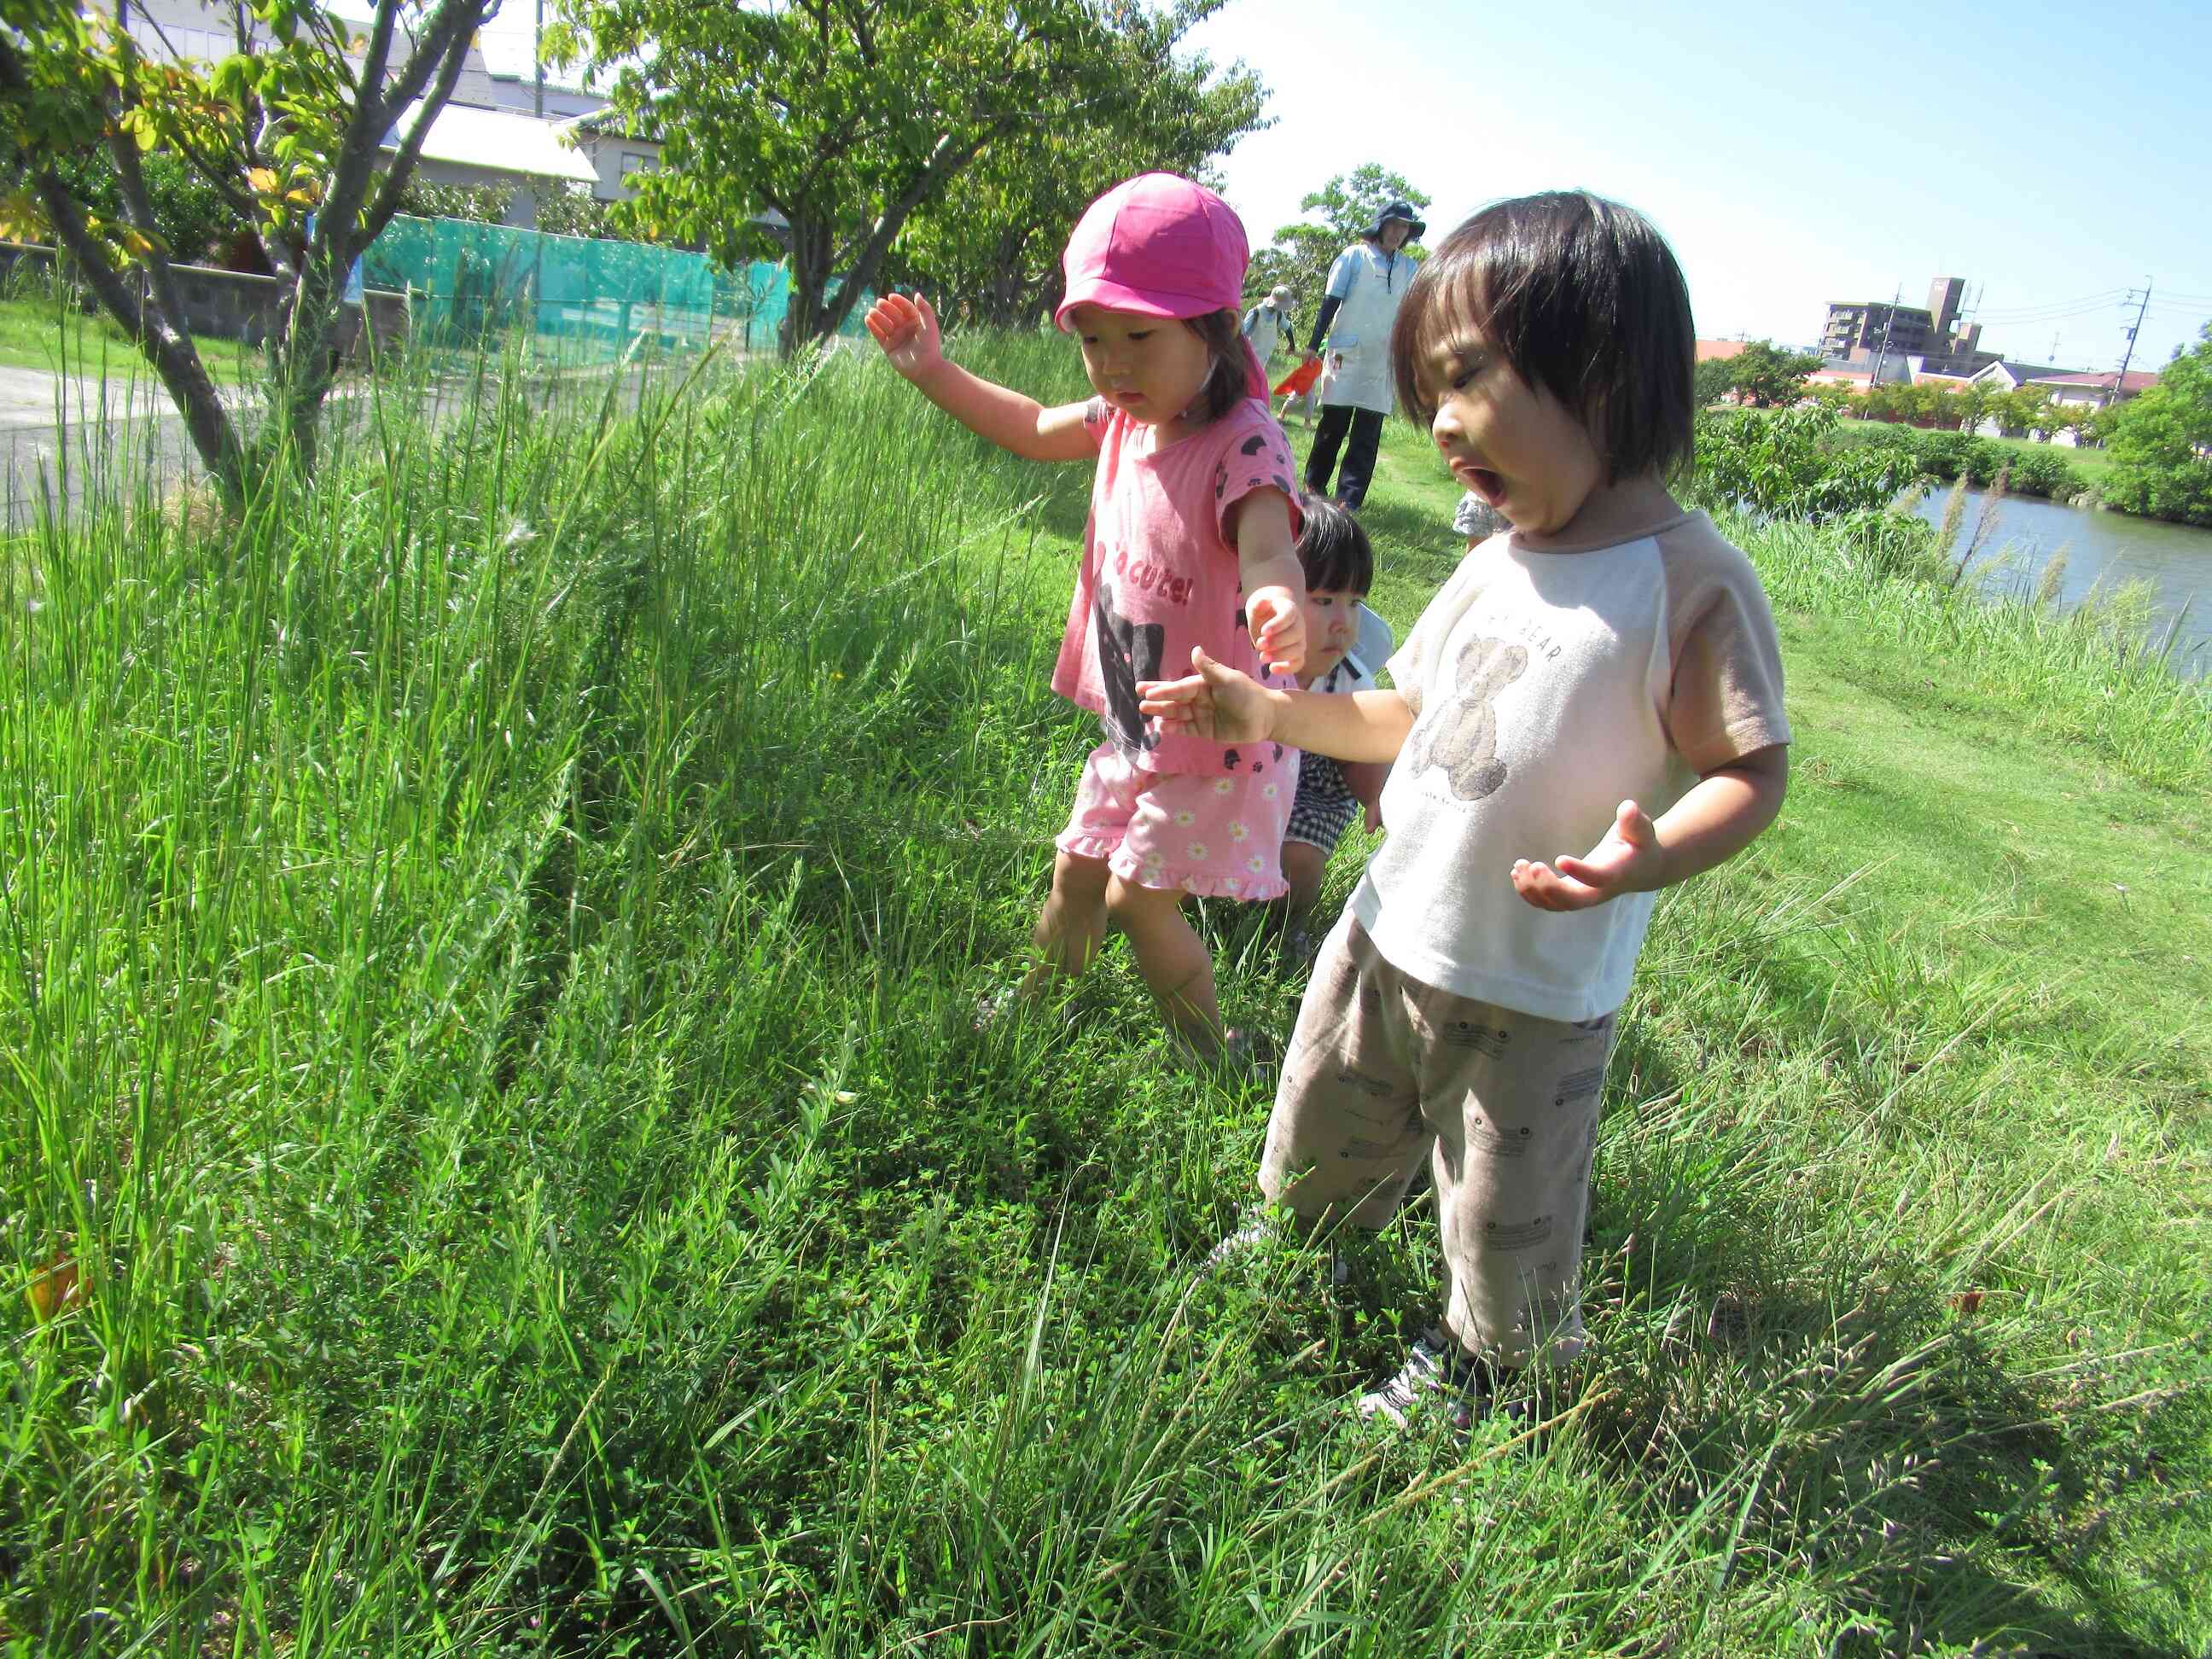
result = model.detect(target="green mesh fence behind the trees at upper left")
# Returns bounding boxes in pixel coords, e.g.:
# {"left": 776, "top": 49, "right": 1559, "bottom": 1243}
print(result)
{"left": 360, "top": 214, "right": 871, "bottom": 358}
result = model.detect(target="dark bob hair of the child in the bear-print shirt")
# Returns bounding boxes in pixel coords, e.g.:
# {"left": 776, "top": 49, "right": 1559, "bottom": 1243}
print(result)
{"left": 1389, "top": 190, "right": 1697, "bottom": 485}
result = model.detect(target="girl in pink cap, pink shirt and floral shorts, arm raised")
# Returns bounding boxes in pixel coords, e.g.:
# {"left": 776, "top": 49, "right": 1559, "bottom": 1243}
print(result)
{"left": 867, "top": 172, "right": 1305, "bottom": 1057}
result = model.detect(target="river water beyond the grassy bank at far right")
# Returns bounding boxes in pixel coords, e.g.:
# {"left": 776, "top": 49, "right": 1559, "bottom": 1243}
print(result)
{"left": 1913, "top": 489, "right": 2212, "bottom": 679}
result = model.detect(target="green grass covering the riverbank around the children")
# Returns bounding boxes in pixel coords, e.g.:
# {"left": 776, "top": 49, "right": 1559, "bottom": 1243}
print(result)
{"left": 0, "top": 341, "right": 2212, "bottom": 1655}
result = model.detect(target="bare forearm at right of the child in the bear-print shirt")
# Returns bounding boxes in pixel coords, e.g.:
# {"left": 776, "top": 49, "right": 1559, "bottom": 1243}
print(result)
{"left": 1513, "top": 743, "right": 1790, "bottom": 909}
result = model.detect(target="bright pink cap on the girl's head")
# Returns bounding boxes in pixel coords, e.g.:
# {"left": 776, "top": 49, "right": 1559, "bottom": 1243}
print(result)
{"left": 1053, "top": 172, "right": 1252, "bottom": 329}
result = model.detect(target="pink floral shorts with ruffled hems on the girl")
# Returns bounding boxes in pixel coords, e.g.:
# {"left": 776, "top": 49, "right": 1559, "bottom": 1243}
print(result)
{"left": 1053, "top": 743, "right": 1299, "bottom": 898}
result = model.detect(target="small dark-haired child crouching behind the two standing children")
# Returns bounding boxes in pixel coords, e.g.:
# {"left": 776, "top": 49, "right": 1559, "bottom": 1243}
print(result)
{"left": 1283, "top": 500, "right": 1391, "bottom": 938}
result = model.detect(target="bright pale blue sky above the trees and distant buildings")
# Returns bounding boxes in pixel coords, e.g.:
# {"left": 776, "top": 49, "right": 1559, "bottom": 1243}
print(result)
{"left": 1188, "top": 0, "right": 2212, "bottom": 370}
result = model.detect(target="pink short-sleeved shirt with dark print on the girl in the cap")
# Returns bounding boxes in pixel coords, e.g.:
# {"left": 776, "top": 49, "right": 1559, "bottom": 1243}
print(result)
{"left": 1053, "top": 399, "right": 1301, "bottom": 772}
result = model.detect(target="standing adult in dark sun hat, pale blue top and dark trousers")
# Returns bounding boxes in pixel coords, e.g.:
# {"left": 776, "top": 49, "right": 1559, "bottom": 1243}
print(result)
{"left": 1305, "top": 201, "right": 1429, "bottom": 509}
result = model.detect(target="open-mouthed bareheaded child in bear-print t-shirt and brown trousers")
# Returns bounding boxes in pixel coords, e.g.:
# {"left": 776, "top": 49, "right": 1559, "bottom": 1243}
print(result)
{"left": 1141, "top": 193, "right": 1790, "bottom": 1424}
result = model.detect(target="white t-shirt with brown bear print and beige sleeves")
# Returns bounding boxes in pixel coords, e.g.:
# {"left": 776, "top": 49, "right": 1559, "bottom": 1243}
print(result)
{"left": 1349, "top": 513, "right": 1790, "bottom": 1020}
